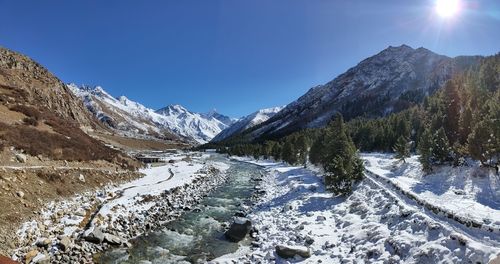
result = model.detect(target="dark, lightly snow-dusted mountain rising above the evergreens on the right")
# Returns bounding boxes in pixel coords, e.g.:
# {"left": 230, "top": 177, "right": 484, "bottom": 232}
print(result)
{"left": 226, "top": 45, "right": 481, "bottom": 140}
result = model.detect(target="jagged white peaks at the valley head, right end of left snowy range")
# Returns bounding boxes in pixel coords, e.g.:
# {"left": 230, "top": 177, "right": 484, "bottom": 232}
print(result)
{"left": 156, "top": 105, "right": 234, "bottom": 143}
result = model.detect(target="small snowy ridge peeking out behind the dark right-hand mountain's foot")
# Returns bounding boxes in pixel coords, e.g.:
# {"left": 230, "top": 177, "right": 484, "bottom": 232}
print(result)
{"left": 212, "top": 106, "right": 283, "bottom": 142}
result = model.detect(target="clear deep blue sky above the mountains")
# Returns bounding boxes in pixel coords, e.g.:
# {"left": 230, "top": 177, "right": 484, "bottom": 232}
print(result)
{"left": 0, "top": 0, "right": 500, "bottom": 117}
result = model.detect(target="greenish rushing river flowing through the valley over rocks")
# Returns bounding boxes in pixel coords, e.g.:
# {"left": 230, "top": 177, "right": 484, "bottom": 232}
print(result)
{"left": 99, "top": 156, "right": 262, "bottom": 263}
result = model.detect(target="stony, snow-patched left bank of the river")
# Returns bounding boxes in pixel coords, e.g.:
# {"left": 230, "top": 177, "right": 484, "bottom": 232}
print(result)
{"left": 8, "top": 155, "right": 227, "bottom": 263}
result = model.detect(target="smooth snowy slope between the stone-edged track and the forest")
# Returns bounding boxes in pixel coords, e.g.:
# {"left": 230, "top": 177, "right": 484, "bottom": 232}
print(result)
{"left": 362, "top": 154, "right": 500, "bottom": 234}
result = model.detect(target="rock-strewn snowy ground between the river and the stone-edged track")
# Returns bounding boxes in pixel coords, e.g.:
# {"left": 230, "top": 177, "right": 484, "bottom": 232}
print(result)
{"left": 213, "top": 155, "right": 500, "bottom": 263}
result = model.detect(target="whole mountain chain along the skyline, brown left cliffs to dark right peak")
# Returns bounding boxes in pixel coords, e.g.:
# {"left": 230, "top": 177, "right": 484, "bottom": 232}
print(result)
{"left": 0, "top": 45, "right": 482, "bottom": 150}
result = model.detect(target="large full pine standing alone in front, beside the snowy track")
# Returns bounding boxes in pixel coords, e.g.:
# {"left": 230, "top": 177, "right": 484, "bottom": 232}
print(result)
{"left": 323, "top": 114, "right": 364, "bottom": 195}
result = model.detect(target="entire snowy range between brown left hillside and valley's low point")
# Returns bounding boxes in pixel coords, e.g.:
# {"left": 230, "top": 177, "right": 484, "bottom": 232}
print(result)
{"left": 68, "top": 84, "right": 234, "bottom": 143}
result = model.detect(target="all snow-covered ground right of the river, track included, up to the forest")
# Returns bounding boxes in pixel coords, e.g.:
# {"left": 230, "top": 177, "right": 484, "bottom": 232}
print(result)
{"left": 213, "top": 154, "right": 500, "bottom": 263}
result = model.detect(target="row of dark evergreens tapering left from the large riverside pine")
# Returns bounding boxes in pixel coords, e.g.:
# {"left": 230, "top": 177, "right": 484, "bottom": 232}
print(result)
{"left": 218, "top": 114, "right": 364, "bottom": 195}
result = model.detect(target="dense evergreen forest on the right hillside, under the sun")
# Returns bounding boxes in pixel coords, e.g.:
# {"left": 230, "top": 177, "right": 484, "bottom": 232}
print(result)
{"left": 348, "top": 55, "right": 500, "bottom": 172}
